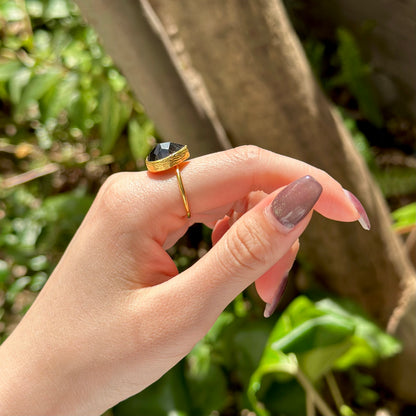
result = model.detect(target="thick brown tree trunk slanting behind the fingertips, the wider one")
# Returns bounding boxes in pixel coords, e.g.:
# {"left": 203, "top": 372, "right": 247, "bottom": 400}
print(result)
{"left": 152, "top": 0, "right": 416, "bottom": 402}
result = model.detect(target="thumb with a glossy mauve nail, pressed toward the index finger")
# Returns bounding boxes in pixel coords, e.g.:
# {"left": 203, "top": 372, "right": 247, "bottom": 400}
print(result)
{"left": 174, "top": 176, "right": 322, "bottom": 324}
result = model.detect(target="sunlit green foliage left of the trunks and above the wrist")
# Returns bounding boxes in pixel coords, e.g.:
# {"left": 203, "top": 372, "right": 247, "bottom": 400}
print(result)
{"left": 0, "top": 0, "right": 155, "bottom": 339}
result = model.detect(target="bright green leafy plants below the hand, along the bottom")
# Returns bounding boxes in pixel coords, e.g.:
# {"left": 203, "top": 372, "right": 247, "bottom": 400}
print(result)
{"left": 113, "top": 296, "right": 400, "bottom": 416}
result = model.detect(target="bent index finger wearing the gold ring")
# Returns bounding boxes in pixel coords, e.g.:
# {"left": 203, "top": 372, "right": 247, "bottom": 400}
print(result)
{"left": 138, "top": 146, "right": 368, "bottom": 237}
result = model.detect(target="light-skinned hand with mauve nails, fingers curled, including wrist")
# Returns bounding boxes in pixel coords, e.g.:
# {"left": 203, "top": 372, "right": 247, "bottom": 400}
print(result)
{"left": 0, "top": 146, "right": 368, "bottom": 415}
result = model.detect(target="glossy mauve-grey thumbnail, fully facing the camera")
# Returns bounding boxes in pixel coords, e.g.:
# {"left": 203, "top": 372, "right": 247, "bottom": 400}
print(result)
{"left": 271, "top": 175, "right": 322, "bottom": 232}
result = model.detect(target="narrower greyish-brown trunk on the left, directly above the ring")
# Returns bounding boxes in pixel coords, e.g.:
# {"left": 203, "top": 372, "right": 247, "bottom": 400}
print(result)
{"left": 77, "top": 0, "right": 230, "bottom": 156}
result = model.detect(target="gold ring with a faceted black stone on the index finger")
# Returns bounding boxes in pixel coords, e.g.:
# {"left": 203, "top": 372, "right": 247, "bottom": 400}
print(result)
{"left": 146, "top": 142, "right": 191, "bottom": 218}
